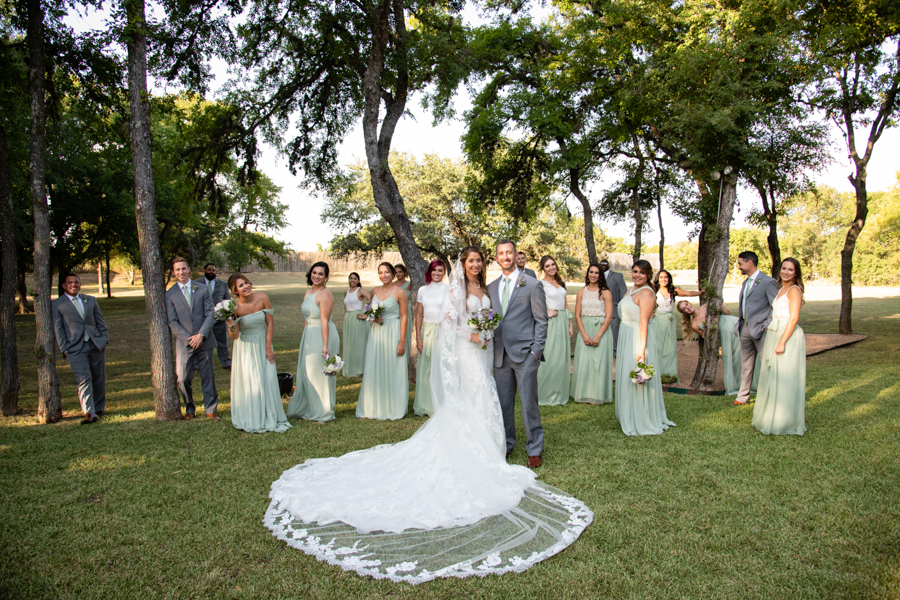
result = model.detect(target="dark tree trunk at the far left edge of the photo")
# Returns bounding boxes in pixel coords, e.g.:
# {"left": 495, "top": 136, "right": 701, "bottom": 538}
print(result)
{"left": 0, "top": 124, "right": 19, "bottom": 417}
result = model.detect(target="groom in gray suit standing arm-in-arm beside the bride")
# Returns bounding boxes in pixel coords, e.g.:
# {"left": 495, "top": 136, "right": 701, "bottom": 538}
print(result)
{"left": 488, "top": 239, "right": 547, "bottom": 469}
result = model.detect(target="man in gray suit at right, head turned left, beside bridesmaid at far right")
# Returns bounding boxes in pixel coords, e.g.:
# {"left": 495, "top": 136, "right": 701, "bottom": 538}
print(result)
{"left": 733, "top": 251, "right": 778, "bottom": 405}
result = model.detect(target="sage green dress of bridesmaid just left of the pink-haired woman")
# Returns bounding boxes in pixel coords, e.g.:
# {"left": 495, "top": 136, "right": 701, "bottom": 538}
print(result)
{"left": 356, "top": 296, "right": 409, "bottom": 421}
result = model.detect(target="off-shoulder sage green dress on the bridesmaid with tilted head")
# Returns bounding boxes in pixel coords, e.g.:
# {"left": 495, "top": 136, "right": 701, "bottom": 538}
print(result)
{"left": 231, "top": 308, "right": 291, "bottom": 433}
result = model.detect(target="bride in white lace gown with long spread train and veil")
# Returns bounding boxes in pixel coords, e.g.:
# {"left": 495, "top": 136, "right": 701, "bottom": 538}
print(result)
{"left": 264, "top": 246, "right": 593, "bottom": 583}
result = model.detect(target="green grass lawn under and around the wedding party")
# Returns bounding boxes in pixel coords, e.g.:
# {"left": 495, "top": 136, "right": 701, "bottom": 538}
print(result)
{"left": 0, "top": 274, "right": 900, "bottom": 600}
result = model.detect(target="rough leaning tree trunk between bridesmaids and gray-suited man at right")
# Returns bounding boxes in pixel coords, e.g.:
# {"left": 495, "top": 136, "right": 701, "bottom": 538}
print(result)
{"left": 691, "top": 177, "right": 737, "bottom": 391}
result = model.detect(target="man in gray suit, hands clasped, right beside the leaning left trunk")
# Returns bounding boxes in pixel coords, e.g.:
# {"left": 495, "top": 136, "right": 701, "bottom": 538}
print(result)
{"left": 166, "top": 256, "right": 219, "bottom": 421}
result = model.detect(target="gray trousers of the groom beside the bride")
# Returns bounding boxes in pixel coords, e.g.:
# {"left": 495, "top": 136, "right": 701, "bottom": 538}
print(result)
{"left": 494, "top": 350, "right": 544, "bottom": 456}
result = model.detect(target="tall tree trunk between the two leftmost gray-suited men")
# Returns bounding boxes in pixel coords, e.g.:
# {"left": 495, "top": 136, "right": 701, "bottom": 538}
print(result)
{"left": 125, "top": 0, "right": 182, "bottom": 421}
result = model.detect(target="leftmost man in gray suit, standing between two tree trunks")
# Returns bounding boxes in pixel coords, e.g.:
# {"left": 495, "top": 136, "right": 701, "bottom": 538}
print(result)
{"left": 51, "top": 273, "right": 109, "bottom": 425}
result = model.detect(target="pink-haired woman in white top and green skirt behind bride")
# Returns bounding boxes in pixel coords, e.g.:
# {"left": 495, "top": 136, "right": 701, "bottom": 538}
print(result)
{"left": 413, "top": 258, "right": 450, "bottom": 417}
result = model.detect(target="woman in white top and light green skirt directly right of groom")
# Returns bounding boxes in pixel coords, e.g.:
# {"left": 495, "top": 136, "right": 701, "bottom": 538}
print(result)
{"left": 538, "top": 256, "right": 572, "bottom": 406}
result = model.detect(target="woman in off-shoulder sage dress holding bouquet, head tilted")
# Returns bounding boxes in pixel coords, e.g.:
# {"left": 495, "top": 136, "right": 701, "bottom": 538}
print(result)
{"left": 225, "top": 273, "right": 291, "bottom": 433}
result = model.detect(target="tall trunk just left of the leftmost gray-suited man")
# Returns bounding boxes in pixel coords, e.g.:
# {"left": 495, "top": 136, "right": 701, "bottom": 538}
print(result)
{"left": 27, "top": 0, "right": 62, "bottom": 423}
